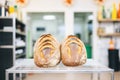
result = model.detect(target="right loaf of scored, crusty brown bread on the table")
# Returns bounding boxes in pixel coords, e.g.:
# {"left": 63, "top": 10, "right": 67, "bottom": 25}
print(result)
{"left": 61, "top": 35, "right": 87, "bottom": 66}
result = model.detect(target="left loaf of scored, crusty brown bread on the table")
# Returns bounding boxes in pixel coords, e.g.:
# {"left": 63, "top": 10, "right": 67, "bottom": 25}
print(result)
{"left": 34, "top": 34, "right": 61, "bottom": 67}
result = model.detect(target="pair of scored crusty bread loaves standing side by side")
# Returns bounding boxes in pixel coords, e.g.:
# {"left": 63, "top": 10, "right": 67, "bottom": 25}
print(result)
{"left": 34, "top": 34, "right": 87, "bottom": 67}
